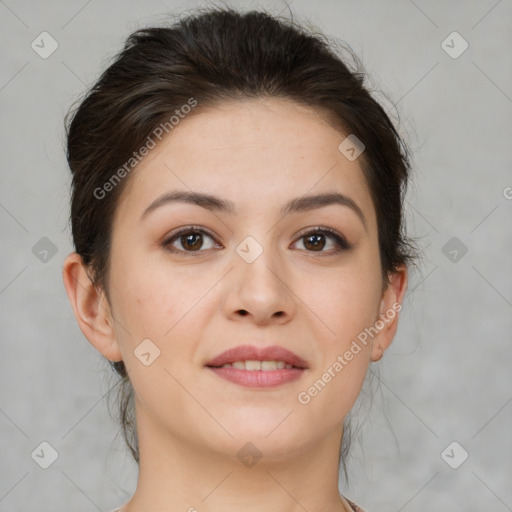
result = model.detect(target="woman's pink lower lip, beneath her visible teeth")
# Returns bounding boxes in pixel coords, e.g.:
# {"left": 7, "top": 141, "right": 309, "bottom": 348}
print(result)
{"left": 208, "top": 366, "right": 304, "bottom": 388}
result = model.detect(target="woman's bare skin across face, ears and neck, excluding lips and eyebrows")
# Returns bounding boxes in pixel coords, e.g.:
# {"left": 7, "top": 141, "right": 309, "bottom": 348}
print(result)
{"left": 63, "top": 99, "right": 407, "bottom": 512}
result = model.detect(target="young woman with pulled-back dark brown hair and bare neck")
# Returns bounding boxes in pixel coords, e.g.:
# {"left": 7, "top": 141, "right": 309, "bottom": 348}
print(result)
{"left": 63, "top": 5, "right": 412, "bottom": 512}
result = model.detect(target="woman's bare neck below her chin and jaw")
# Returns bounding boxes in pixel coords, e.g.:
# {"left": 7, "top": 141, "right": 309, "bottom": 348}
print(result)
{"left": 122, "top": 410, "right": 351, "bottom": 512}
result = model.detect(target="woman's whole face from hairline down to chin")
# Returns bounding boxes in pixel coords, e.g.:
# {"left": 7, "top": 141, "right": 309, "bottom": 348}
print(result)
{"left": 95, "top": 99, "right": 404, "bottom": 457}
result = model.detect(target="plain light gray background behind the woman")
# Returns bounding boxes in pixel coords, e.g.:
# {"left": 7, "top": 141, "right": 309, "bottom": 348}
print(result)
{"left": 0, "top": 0, "right": 512, "bottom": 512}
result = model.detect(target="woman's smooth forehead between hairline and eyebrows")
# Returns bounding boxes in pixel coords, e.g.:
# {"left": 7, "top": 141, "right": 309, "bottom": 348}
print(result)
{"left": 118, "top": 98, "right": 374, "bottom": 226}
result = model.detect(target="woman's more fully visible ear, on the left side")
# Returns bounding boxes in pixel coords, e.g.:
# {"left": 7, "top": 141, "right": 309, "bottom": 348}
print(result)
{"left": 62, "top": 252, "right": 123, "bottom": 361}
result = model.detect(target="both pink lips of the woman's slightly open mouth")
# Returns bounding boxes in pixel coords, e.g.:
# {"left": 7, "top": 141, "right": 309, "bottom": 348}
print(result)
{"left": 206, "top": 345, "right": 308, "bottom": 388}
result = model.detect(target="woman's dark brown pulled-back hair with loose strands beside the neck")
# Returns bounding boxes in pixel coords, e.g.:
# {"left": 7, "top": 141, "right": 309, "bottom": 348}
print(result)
{"left": 66, "top": 8, "right": 414, "bottom": 482}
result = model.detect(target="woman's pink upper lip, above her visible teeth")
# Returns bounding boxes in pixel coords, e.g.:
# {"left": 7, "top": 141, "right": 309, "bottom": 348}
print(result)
{"left": 206, "top": 345, "right": 308, "bottom": 368}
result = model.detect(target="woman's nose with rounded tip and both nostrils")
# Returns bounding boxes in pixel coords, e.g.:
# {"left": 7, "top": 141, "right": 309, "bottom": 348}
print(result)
{"left": 224, "top": 242, "right": 297, "bottom": 325}
